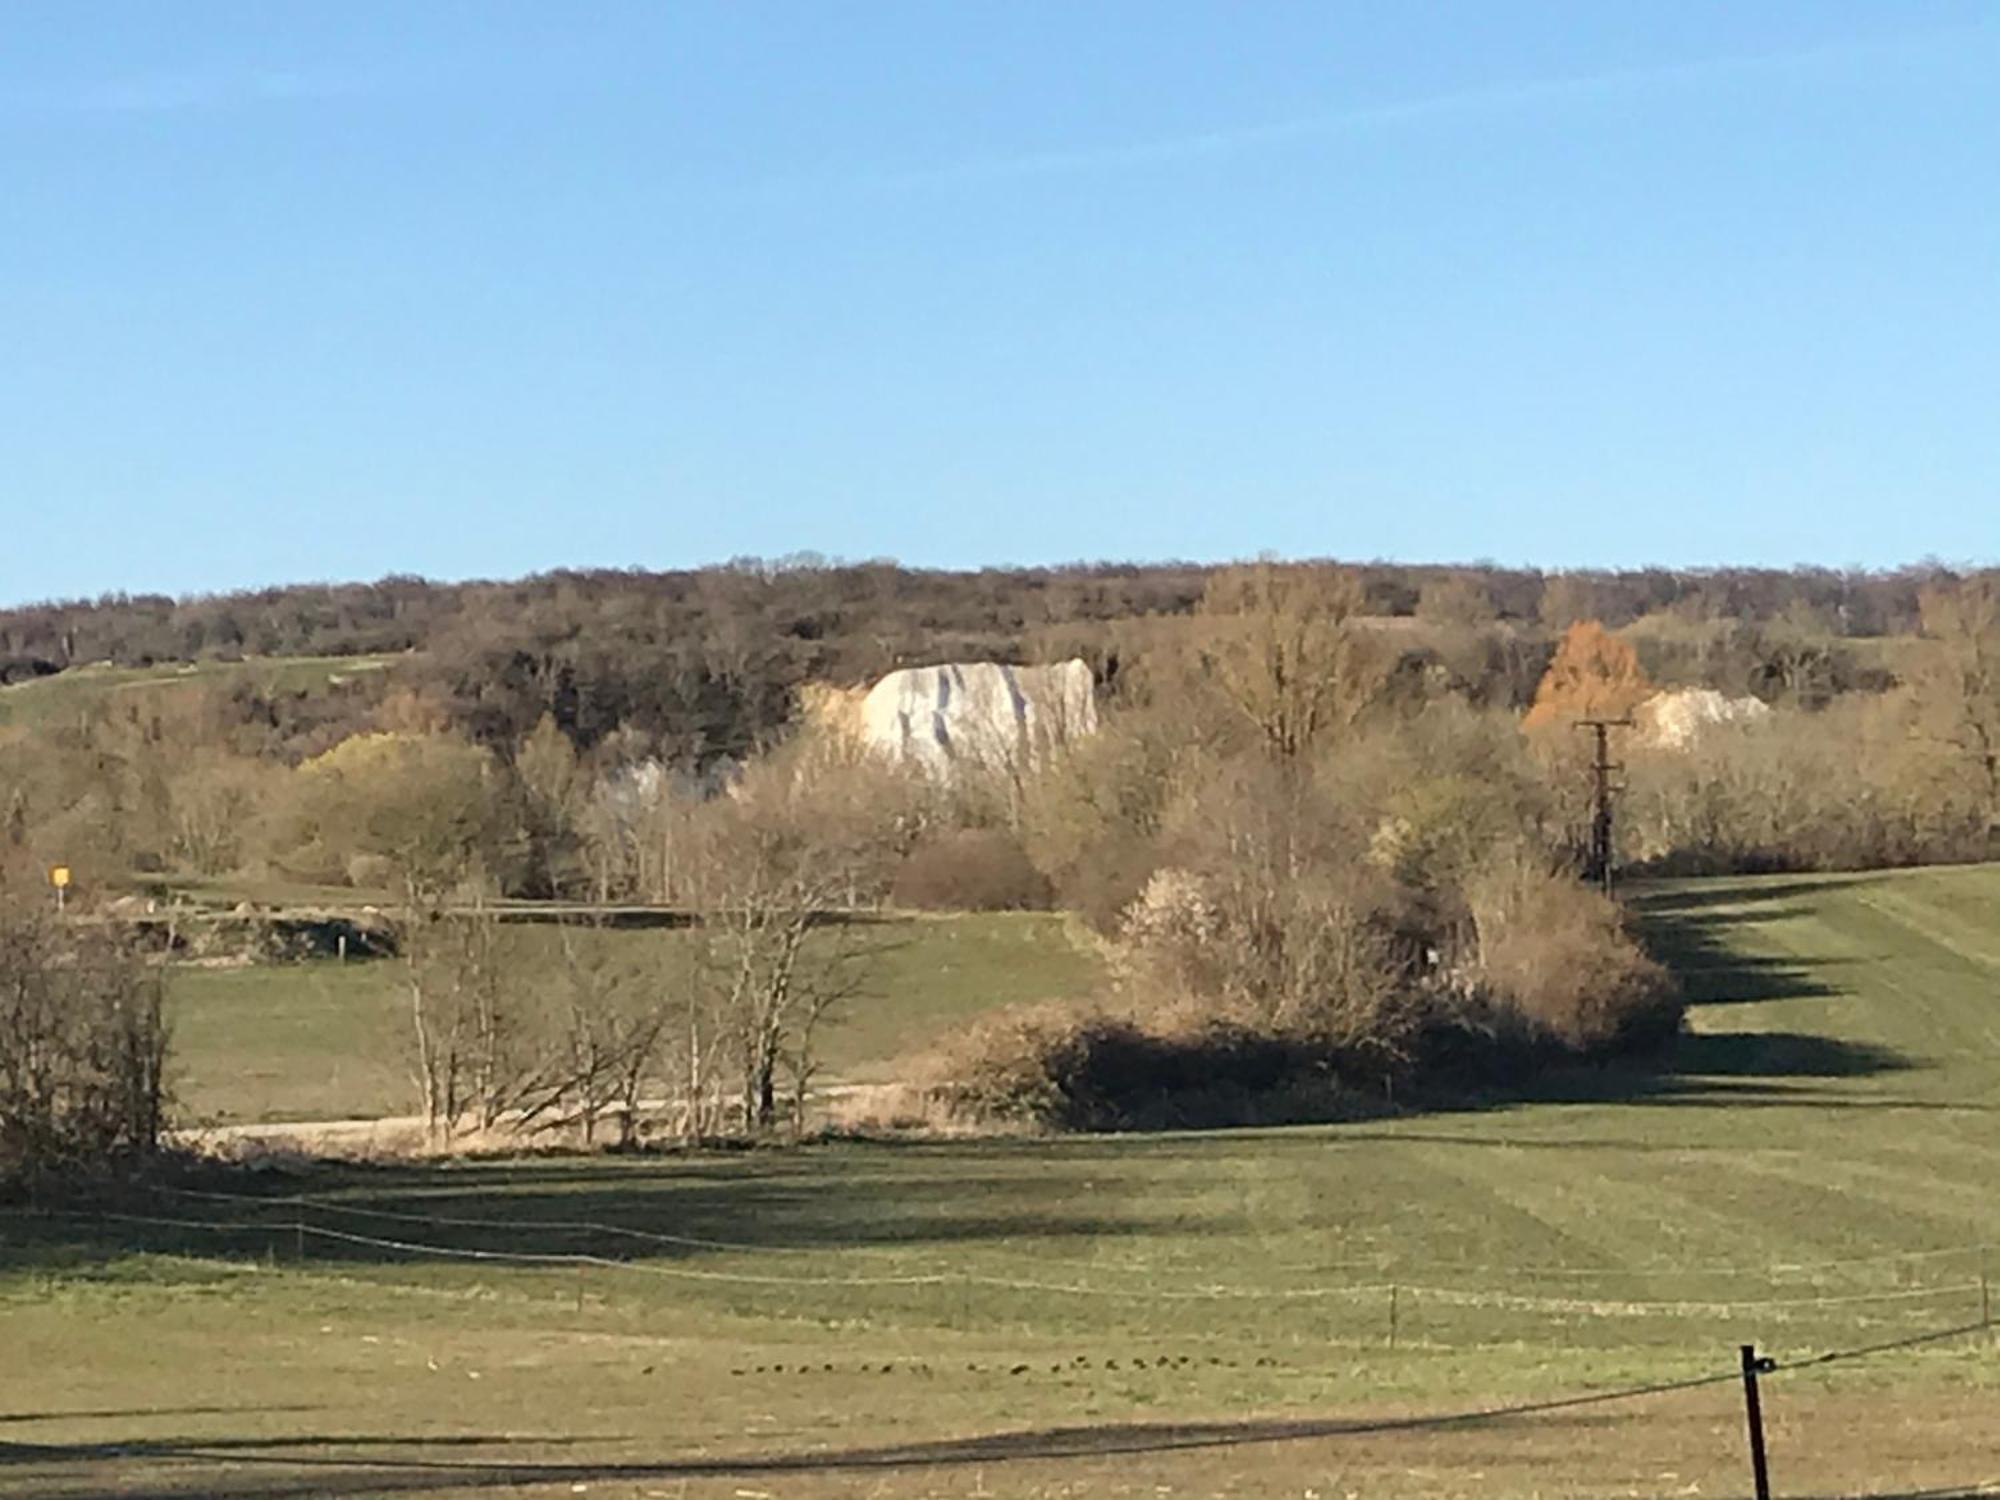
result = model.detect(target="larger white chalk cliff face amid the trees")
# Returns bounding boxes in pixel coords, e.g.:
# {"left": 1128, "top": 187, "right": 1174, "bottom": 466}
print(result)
{"left": 858, "top": 658, "right": 1098, "bottom": 774}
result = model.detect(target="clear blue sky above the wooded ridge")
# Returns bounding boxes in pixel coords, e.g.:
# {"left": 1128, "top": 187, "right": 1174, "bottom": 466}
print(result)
{"left": 0, "top": 0, "right": 2000, "bottom": 600}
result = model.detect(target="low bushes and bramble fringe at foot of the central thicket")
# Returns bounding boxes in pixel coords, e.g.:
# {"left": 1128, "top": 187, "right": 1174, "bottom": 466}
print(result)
{"left": 918, "top": 840, "right": 1682, "bottom": 1130}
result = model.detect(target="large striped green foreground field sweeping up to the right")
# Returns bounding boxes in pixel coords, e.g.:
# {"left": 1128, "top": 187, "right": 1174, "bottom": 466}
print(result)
{"left": 0, "top": 868, "right": 2000, "bottom": 1500}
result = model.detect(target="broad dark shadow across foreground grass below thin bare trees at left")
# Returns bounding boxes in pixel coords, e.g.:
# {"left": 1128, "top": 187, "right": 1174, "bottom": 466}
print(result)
{"left": 0, "top": 1148, "right": 1200, "bottom": 1290}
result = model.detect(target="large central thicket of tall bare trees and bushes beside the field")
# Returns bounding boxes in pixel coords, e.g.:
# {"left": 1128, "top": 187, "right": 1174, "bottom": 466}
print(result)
{"left": 924, "top": 572, "right": 1680, "bottom": 1128}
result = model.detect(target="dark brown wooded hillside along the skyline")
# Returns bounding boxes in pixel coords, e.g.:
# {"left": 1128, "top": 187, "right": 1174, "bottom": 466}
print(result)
{"left": 0, "top": 558, "right": 1946, "bottom": 764}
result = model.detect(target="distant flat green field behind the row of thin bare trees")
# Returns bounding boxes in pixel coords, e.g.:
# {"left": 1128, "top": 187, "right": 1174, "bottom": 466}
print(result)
{"left": 168, "top": 912, "right": 1098, "bottom": 1124}
